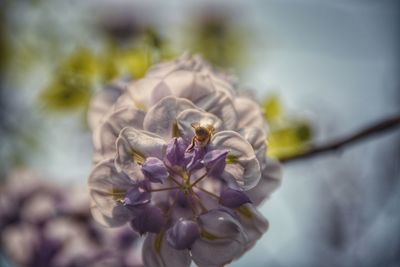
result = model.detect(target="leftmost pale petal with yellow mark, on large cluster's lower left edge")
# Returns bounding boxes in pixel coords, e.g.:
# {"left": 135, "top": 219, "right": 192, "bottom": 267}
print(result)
{"left": 89, "top": 159, "right": 134, "bottom": 220}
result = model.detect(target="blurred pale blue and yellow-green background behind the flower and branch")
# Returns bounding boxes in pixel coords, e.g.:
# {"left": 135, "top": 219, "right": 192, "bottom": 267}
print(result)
{"left": 0, "top": 0, "right": 400, "bottom": 267}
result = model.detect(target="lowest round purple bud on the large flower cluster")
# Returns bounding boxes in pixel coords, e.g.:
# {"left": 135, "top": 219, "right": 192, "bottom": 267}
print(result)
{"left": 167, "top": 218, "right": 200, "bottom": 250}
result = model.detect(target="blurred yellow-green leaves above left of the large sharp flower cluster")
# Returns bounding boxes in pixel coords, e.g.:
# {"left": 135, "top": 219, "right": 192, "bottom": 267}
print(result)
{"left": 40, "top": 30, "right": 173, "bottom": 112}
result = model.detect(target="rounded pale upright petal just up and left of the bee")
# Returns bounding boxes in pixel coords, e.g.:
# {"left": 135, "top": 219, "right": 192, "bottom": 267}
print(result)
{"left": 143, "top": 96, "right": 196, "bottom": 141}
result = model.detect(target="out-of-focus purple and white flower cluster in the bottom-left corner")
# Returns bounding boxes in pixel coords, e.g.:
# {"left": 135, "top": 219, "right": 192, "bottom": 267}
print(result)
{"left": 0, "top": 170, "right": 142, "bottom": 267}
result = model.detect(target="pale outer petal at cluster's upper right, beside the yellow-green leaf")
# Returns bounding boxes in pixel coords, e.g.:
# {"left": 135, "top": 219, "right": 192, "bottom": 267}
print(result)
{"left": 234, "top": 97, "right": 267, "bottom": 130}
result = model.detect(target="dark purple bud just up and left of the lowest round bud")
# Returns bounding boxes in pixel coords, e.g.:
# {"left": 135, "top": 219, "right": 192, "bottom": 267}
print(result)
{"left": 131, "top": 206, "right": 165, "bottom": 235}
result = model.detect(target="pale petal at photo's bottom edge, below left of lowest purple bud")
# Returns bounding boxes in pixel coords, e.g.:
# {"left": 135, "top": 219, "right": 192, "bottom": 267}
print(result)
{"left": 142, "top": 233, "right": 192, "bottom": 267}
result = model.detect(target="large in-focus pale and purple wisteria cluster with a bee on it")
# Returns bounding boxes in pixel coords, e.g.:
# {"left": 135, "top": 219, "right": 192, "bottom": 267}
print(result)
{"left": 89, "top": 55, "right": 281, "bottom": 266}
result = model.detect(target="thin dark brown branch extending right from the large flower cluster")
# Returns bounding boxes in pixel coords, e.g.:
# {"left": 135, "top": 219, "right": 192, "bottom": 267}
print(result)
{"left": 279, "top": 115, "right": 400, "bottom": 163}
